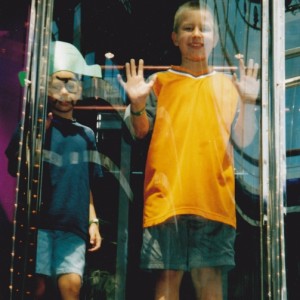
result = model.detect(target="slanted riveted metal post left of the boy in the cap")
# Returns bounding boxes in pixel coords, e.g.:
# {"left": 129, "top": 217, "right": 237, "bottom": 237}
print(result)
{"left": 10, "top": 0, "right": 53, "bottom": 300}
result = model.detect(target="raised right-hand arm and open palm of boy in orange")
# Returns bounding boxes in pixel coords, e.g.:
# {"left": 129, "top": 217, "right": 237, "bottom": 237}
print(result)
{"left": 232, "top": 58, "right": 260, "bottom": 148}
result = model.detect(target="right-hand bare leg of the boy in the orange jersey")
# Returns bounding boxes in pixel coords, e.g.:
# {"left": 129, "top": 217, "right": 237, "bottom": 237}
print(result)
{"left": 191, "top": 268, "right": 223, "bottom": 300}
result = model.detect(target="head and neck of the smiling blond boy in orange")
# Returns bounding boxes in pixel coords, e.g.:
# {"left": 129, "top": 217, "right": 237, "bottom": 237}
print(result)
{"left": 172, "top": 8, "right": 218, "bottom": 68}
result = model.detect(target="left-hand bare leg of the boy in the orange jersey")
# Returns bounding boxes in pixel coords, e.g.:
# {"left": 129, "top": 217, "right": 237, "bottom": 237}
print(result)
{"left": 155, "top": 270, "right": 183, "bottom": 300}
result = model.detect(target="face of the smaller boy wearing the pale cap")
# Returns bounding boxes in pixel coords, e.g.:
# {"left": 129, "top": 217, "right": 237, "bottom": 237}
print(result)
{"left": 48, "top": 71, "right": 82, "bottom": 118}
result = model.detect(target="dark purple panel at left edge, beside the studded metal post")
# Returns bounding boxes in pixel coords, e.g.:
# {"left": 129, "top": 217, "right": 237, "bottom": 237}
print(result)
{"left": 0, "top": 35, "right": 25, "bottom": 221}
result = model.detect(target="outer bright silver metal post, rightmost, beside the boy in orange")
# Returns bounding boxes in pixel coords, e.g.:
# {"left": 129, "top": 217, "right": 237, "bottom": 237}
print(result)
{"left": 267, "top": 0, "right": 287, "bottom": 299}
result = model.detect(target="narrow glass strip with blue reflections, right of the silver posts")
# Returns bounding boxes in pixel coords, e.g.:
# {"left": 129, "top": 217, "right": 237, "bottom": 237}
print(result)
{"left": 285, "top": 1, "right": 300, "bottom": 299}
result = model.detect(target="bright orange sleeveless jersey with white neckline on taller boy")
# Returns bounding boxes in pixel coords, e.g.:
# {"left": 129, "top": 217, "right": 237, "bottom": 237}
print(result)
{"left": 143, "top": 68, "right": 238, "bottom": 227}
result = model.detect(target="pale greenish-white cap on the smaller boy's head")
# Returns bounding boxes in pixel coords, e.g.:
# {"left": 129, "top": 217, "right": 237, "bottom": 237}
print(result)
{"left": 49, "top": 41, "right": 102, "bottom": 78}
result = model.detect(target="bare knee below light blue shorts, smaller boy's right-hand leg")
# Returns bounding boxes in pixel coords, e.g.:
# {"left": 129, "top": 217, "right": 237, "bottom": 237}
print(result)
{"left": 58, "top": 273, "right": 81, "bottom": 300}
